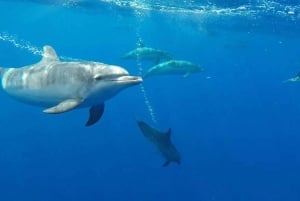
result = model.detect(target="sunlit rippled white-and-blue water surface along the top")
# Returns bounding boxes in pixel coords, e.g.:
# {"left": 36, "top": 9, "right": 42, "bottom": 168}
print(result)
{"left": 100, "top": 0, "right": 300, "bottom": 20}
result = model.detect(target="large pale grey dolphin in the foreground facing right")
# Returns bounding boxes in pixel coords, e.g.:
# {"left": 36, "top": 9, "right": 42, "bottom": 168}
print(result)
{"left": 0, "top": 46, "right": 142, "bottom": 126}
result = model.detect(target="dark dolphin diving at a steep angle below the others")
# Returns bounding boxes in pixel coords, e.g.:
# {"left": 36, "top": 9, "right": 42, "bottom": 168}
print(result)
{"left": 137, "top": 120, "right": 181, "bottom": 167}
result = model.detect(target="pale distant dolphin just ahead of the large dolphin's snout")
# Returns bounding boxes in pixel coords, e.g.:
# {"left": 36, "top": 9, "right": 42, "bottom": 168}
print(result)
{"left": 143, "top": 60, "right": 203, "bottom": 78}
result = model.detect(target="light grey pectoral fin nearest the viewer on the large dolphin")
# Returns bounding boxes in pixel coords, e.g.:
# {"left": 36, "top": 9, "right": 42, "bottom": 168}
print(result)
{"left": 44, "top": 99, "right": 82, "bottom": 114}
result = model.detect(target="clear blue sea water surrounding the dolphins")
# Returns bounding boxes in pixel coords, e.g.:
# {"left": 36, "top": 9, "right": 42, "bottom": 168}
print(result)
{"left": 0, "top": 0, "right": 300, "bottom": 201}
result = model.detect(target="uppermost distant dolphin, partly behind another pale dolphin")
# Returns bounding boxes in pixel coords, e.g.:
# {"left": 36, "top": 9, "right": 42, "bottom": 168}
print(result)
{"left": 122, "top": 47, "right": 172, "bottom": 64}
